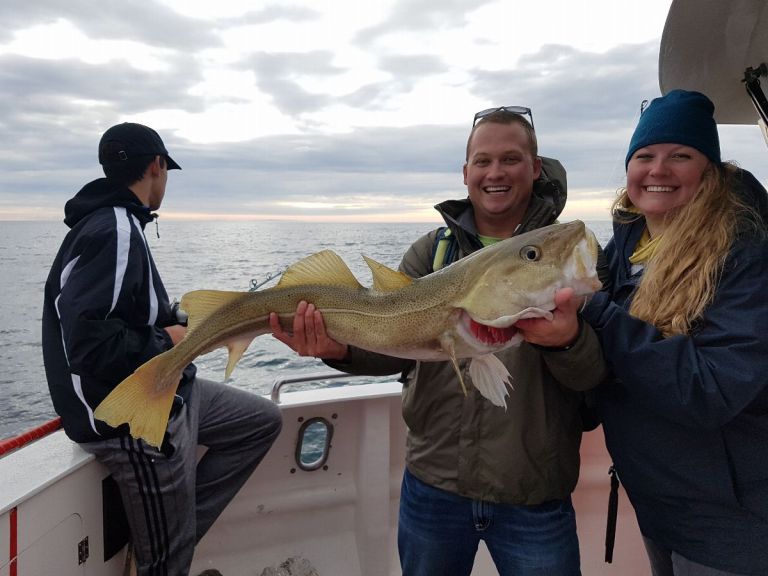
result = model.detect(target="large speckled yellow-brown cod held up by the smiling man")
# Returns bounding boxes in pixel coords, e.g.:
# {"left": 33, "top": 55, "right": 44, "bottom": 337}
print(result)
{"left": 95, "top": 220, "right": 600, "bottom": 446}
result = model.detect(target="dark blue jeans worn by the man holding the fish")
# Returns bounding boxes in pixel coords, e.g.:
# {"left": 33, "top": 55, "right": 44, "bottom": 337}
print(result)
{"left": 397, "top": 469, "right": 581, "bottom": 576}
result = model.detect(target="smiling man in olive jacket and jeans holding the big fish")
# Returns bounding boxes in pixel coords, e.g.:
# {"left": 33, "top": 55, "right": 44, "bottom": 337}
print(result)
{"left": 270, "top": 106, "right": 605, "bottom": 576}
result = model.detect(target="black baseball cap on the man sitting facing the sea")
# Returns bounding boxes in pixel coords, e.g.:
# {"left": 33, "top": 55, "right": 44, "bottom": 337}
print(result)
{"left": 99, "top": 122, "right": 181, "bottom": 170}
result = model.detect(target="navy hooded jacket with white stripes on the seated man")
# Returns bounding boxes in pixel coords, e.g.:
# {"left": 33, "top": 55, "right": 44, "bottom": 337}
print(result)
{"left": 43, "top": 178, "right": 195, "bottom": 442}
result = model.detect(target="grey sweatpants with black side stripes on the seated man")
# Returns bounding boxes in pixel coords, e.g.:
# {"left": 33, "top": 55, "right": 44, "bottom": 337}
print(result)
{"left": 81, "top": 378, "right": 282, "bottom": 576}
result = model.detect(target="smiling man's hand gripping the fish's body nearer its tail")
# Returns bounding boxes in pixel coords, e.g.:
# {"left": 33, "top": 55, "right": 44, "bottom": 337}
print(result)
{"left": 269, "top": 300, "right": 348, "bottom": 360}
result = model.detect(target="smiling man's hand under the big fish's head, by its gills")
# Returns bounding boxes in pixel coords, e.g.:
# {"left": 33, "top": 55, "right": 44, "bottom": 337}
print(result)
{"left": 515, "top": 288, "right": 585, "bottom": 348}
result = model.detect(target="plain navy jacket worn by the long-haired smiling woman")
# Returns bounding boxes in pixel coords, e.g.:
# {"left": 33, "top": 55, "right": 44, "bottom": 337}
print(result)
{"left": 583, "top": 169, "right": 768, "bottom": 576}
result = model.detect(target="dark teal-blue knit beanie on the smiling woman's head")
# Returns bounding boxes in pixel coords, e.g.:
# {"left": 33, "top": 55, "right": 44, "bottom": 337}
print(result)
{"left": 624, "top": 90, "right": 720, "bottom": 168}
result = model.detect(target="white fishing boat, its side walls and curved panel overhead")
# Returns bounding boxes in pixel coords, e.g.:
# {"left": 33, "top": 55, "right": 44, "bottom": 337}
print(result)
{"left": 0, "top": 0, "right": 768, "bottom": 576}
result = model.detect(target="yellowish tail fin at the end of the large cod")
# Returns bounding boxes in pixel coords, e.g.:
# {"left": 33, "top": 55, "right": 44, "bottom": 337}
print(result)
{"left": 94, "top": 352, "right": 181, "bottom": 448}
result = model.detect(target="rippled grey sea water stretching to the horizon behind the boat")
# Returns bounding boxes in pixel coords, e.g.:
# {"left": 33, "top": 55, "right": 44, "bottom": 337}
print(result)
{"left": 0, "top": 217, "right": 611, "bottom": 439}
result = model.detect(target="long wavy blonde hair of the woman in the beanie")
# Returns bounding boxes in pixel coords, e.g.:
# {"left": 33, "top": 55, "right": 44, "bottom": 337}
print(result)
{"left": 612, "top": 162, "right": 762, "bottom": 337}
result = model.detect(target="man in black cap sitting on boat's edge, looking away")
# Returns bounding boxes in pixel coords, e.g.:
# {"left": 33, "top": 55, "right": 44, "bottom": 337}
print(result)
{"left": 43, "top": 123, "right": 281, "bottom": 575}
